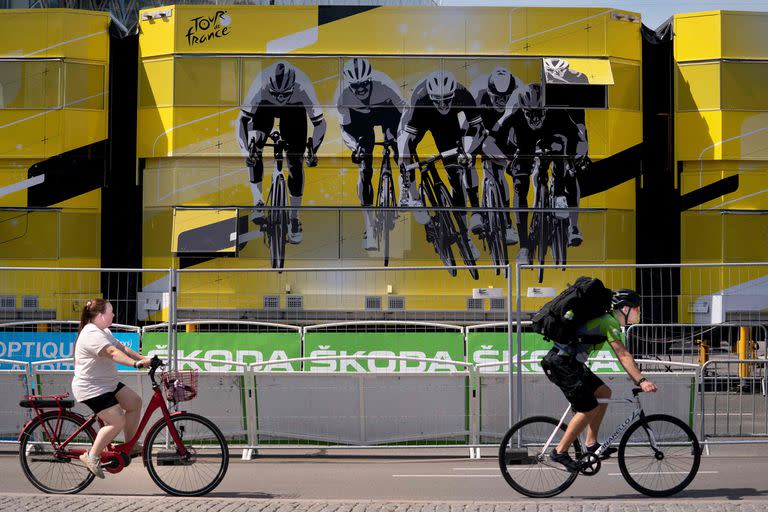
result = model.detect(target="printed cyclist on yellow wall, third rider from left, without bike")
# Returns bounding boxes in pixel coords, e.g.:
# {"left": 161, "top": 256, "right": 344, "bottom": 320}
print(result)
{"left": 397, "top": 71, "right": 486, "bottom": 259}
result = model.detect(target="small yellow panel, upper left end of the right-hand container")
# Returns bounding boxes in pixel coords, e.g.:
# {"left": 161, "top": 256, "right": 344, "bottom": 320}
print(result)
{"left": 675, "top": 62, "right": 720, "bottom": 112}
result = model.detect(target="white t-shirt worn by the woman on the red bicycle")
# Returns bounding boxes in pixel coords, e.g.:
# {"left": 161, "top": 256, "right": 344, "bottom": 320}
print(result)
{"left": 72, "top": 323, "right": 125, "bottom": 402}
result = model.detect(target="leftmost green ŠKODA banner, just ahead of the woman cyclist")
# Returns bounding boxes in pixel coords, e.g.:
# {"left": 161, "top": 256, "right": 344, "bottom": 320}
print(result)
{"left": 142, "top": 332, "right": 301, "bottom": 372}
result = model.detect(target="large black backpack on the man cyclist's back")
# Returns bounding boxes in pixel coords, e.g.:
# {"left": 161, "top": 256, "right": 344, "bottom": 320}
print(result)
{"left": 533, "top": 276, "right": 613, "bottom": 344}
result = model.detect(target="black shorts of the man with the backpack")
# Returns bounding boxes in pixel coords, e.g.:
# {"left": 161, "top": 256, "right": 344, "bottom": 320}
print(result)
{"left": 541, "top": 348, "right": 605, "bottom": 412}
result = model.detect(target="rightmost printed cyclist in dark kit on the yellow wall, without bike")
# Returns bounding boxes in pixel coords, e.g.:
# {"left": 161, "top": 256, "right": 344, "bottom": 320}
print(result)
{"left": 493, "top": 83, "right": 590, "bottom": 262}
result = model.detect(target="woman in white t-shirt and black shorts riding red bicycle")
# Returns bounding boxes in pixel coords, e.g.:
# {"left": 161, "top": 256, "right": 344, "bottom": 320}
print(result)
{"left": 72, "top": 299, "right": 150, "bottom": 478}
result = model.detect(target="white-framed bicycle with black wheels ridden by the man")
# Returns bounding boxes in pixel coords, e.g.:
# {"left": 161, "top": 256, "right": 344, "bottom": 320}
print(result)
{"left": 499, "top": 388, "right": 701, "bottom": 498}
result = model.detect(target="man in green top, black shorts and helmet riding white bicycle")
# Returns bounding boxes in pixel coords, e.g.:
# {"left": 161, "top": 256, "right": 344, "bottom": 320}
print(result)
{"left": 541, "top": 289, "right": 657, "bottom": 472}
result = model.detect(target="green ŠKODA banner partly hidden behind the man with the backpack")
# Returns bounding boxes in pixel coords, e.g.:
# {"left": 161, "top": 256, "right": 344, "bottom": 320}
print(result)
{"left": 467, "top": 330, "right": 623, "bottom": 373}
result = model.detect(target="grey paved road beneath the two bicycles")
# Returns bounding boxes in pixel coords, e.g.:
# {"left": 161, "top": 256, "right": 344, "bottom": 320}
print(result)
{"left": 0, "top": 445, "right": 768, "bottom": 512}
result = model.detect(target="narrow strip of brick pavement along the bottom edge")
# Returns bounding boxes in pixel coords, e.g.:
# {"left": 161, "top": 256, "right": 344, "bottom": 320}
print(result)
{"left": 0, "top": 493, "right": 768, "bottom": 512}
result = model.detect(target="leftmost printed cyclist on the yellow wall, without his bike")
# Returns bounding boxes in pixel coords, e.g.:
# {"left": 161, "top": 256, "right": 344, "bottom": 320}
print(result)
{"left": 235, "top": 61, "right": 326, "bottom": 244}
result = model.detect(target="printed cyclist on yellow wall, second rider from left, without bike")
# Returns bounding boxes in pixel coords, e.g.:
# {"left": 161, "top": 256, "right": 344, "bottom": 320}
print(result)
{"left": 336, "top": 57, "right": 405, "bottom": 251}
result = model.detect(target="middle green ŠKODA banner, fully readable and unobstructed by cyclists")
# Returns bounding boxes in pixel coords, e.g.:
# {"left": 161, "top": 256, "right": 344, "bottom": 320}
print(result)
{"left": 304, "top": 330, "right": 464, "bottom": 373}
